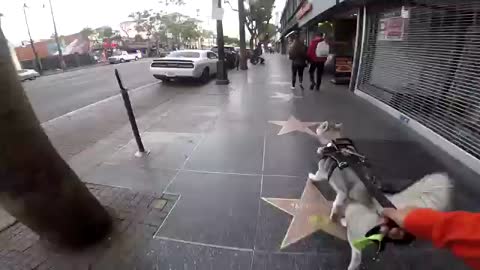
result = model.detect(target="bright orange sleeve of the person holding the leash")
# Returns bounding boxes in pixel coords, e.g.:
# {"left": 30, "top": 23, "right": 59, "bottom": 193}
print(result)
{"left": 405, "top": 209, "right": 480, "bottom": 269}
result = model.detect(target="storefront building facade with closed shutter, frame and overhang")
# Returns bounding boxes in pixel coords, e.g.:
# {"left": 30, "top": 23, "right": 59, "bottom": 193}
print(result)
{"left": 282, "top": 0, "right": 480, "bottom": 172}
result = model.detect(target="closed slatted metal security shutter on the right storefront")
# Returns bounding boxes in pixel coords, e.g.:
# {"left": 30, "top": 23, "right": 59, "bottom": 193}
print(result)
{"left": 358, "top": 1, "right": 480, "bottom": 158}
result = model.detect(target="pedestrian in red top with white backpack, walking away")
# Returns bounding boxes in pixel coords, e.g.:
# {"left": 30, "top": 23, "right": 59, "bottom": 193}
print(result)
{"left": 307, "top": 32, "right": 329, "bottom": 91}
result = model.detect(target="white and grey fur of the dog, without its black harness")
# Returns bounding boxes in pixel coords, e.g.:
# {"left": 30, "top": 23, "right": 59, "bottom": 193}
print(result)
{"left": 308, "top": 122, "right": 453, "bottom": 270}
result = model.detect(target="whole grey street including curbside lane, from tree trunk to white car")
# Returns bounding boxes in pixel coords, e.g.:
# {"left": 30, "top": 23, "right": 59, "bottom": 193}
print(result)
{"left": 29, "top": 59, "right": 208, "bottom": 161}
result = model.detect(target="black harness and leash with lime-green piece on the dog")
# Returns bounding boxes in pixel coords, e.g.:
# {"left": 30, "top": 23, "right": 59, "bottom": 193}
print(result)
{"left": 316, "top": 138, "right": 415, "bottom": 254}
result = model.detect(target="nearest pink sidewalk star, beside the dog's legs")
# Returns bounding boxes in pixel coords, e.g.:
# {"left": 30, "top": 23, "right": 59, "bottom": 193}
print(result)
{"left": 262, "top": 180, "right": 347, "bottom": 249}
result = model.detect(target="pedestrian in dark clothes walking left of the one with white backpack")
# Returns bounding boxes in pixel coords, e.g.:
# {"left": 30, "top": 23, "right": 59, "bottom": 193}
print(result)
{"left": 288, "top": 34, "right": 307, "bottom": 90}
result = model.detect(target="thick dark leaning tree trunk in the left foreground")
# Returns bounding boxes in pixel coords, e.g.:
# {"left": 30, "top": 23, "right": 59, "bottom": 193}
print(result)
{"left": 0, "top": 29, "right": 112, "bottom": 248}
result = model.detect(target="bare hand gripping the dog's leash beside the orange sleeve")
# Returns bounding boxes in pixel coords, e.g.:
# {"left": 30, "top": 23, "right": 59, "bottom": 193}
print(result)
{"left": 380, "top": 208, "right": 415, "bottom": 240}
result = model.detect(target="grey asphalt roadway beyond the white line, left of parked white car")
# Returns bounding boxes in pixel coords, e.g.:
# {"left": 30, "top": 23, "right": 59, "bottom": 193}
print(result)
{"left": 24, "top": 59, "right": 158, "bottom": 122}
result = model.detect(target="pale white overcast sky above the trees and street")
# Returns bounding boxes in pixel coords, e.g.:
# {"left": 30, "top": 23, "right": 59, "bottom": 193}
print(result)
{"left": 0, "top": 0, "right": 285, "bottom": 45}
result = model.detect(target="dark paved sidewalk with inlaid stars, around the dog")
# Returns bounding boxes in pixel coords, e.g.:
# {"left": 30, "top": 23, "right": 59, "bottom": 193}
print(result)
{"left": 0, "top": 55, "right": 480, "bottom": 270}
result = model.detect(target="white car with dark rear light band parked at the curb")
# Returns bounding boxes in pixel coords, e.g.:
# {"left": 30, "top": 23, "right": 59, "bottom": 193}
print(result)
{"left": 150, "top": 50, "right": 218, "bottom": 82}
